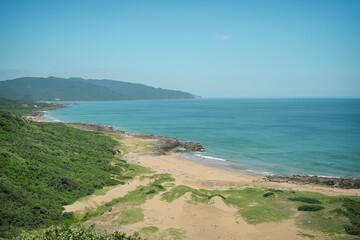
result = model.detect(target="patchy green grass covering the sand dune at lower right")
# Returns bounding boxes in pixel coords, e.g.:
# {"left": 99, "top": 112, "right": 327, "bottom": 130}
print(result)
{"left": 161, "top": 186, "right": 360, "bottom": 237}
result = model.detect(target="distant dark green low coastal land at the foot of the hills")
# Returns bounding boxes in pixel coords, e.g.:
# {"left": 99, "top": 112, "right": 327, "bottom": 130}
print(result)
{"left": 0, "top": 97, "right": 63, "bottom": 116}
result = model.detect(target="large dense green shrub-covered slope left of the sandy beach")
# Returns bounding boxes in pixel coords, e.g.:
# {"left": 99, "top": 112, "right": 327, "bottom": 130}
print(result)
{"left": 0, "top": 112, "right": 145, "bottom": 237}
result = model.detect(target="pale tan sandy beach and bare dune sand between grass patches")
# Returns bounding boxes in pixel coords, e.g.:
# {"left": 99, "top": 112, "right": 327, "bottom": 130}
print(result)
{"left": 26, "top": 115, "right": 360, "bottom": 240}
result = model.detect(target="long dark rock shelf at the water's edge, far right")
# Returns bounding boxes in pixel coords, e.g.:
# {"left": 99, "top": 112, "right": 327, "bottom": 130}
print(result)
{"left": 265, "top": 175, "right": 360, "bottom": 189}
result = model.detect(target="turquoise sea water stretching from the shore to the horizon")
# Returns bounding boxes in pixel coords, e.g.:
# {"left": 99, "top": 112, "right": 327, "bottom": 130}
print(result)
{"left": 44, "top": 99, "right": 360, "bottom": 177}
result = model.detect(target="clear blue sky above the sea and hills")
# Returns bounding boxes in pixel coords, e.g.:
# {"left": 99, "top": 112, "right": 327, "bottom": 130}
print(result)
{"left": 0, "top": 0, "right": 360, "bottom": 97}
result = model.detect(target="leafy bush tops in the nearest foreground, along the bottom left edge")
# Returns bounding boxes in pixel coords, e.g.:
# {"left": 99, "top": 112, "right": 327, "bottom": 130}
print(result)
{"left": 10, "top": 224, "right": 141, "bottom": 240}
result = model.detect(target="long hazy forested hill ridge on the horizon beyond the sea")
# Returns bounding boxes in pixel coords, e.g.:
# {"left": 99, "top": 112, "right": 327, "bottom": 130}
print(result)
{"left": 0, "top": 77, "right": 195, "bottom": 101}
